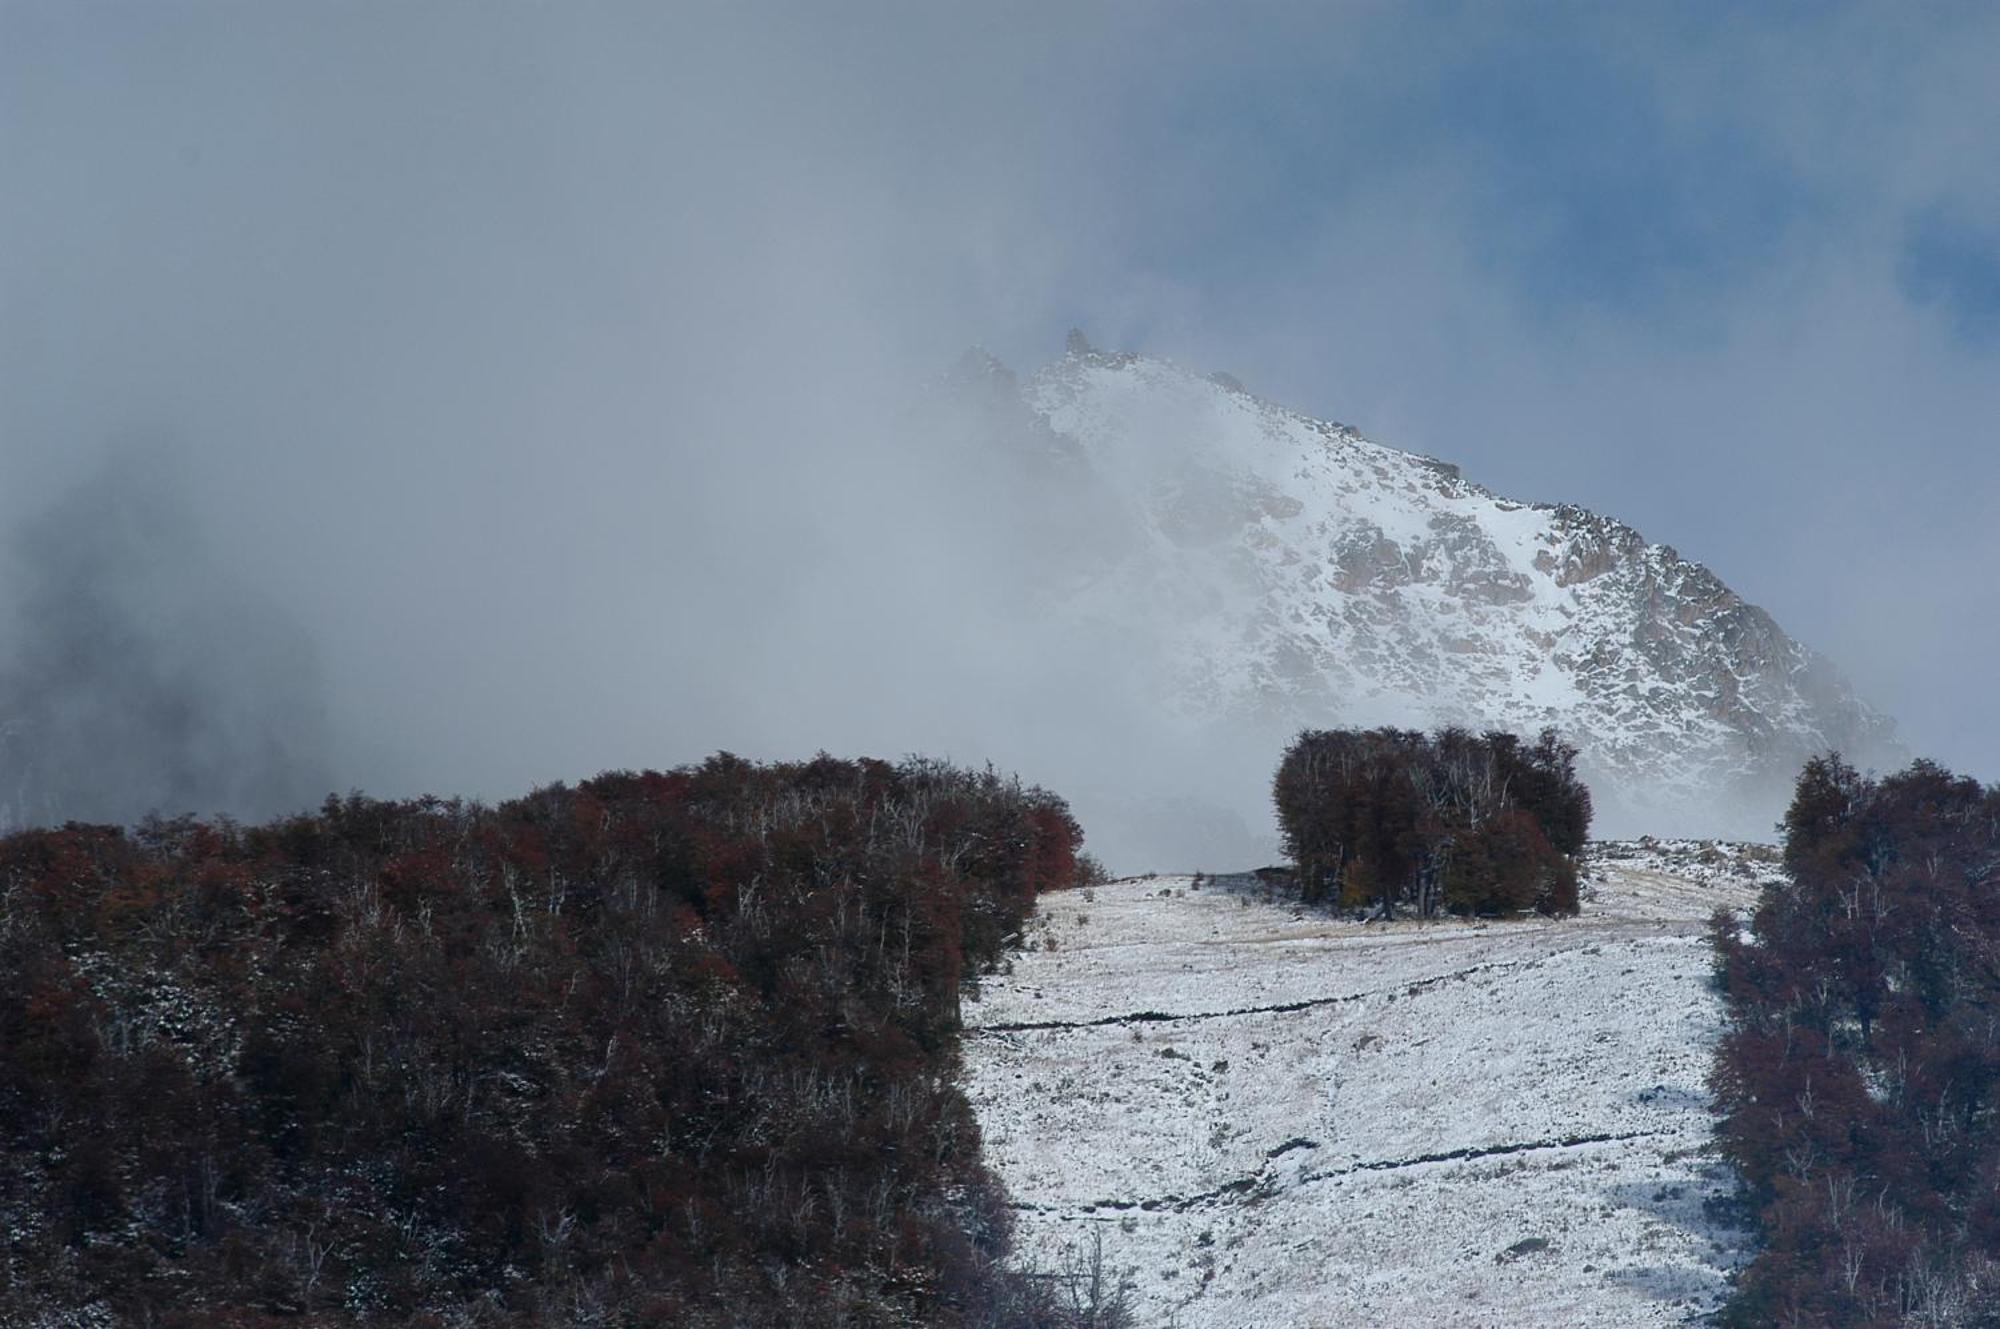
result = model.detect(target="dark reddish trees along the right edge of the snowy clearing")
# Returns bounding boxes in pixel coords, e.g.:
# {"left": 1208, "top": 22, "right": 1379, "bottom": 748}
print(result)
{"left": 1712, "top": 757, "right": 2000, "bottom": 1327}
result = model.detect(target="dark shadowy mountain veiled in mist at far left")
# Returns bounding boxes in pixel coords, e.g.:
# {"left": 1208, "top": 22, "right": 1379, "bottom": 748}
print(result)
{"left": 0, "top": 454, "right": 330, "bottom": 831}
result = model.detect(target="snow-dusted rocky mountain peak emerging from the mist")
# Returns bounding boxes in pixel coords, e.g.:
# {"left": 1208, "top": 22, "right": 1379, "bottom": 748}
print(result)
{"left": 994, "top": 336, "right": 1892, "bottom": 835}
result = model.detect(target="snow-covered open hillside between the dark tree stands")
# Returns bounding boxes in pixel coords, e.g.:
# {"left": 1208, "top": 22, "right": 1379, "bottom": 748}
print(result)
{"left": 966, "top": 843, "right": 1766, "bottom": 1329}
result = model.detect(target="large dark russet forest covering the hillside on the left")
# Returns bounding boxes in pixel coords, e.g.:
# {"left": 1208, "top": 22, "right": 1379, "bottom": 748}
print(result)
{"left": 0, "top": 755, "right": 1112, "bottom": 1329}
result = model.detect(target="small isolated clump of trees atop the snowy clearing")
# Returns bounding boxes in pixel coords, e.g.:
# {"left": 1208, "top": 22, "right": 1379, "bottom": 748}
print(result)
{"left": 1272, "top": 729, "right": 1590, "bottom": 917}
